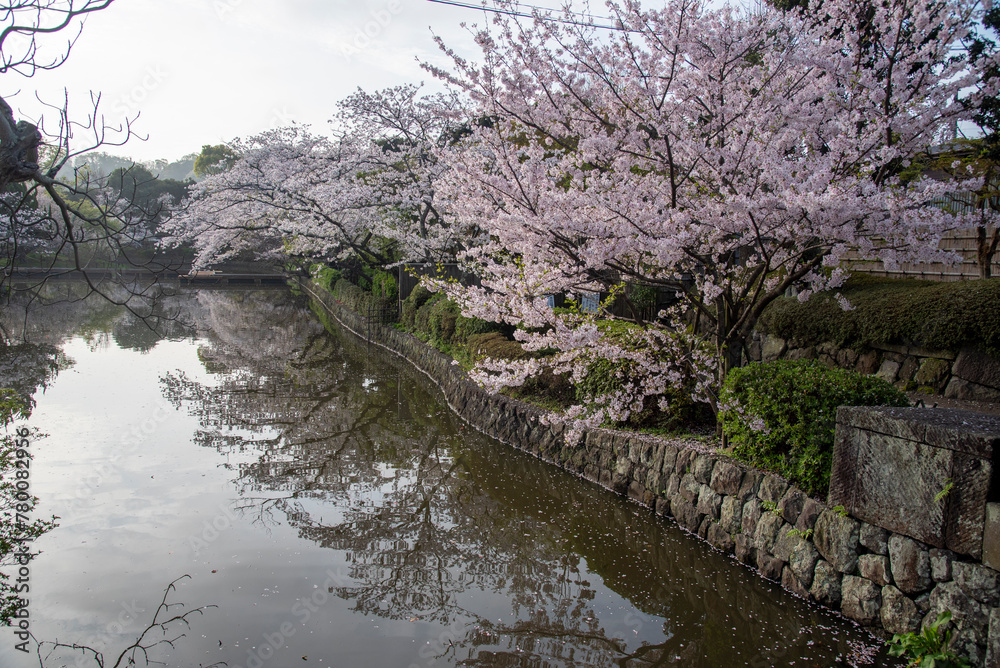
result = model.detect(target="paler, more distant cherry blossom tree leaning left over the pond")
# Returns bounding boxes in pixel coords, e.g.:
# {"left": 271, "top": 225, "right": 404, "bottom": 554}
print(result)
{"left": 168, "top": 86, "right": 457, "bottom": 274}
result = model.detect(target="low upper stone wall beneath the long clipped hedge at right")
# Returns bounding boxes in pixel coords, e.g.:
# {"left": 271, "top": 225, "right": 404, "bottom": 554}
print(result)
{"left": 749, "top": 332, "right": 1000, "bottom": 402}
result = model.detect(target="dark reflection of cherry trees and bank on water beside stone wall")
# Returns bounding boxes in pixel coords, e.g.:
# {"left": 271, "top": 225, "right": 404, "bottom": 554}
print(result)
{"left": 163, "top": 293, "right": 880, "bottom": 666}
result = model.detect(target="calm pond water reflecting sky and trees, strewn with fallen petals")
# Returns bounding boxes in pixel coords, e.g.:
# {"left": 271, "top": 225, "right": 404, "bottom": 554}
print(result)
{"left": 0, "top": 286, "right": 888, "bottom": 668}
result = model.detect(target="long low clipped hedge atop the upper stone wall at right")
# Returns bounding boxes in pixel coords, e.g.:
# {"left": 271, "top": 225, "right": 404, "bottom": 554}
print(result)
{"left": 758, "top": 275, "right": 1000, "bottom": 355}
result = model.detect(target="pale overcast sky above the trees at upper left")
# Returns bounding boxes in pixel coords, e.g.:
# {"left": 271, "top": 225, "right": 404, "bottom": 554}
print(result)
{"left": 2, "top": 0, "right": 564, "bottom": 160}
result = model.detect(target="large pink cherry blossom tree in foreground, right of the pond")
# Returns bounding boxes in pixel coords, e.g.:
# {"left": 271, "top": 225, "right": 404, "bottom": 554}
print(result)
{"left": 427, "top": 0, "right": 996, "bottom": 424}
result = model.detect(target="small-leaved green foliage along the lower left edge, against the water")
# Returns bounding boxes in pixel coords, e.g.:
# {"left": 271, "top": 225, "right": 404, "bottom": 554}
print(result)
{"left": 0, "top": 390, "right": 57, "bottom": 624}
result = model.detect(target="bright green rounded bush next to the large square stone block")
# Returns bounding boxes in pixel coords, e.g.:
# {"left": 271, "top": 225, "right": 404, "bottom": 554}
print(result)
{"left": 719, "top": 360, "right": 910, "bottom": 495}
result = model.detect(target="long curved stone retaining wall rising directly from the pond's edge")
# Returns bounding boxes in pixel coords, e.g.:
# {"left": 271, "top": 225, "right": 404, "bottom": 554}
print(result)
{"left": 299, "top": 281, "right": 1000, "bottom": 667}
